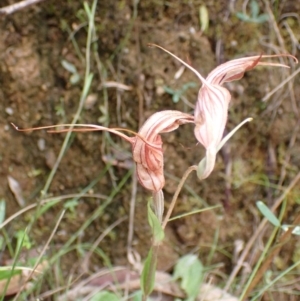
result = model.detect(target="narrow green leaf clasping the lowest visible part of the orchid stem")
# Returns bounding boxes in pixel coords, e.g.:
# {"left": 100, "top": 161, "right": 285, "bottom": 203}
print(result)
{"left": 141, "top": 248, "right": 157, "bottom": 296}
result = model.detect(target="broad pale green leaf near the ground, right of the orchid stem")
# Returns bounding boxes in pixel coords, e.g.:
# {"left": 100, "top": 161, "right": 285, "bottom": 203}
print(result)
{"left": 174, "top": 254, "right": 203, "bottom": 300}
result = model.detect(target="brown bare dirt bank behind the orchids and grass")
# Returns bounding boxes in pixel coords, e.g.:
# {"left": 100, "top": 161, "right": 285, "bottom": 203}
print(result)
{"left": 0, "top": 0, "right": 300, "bottom": 300}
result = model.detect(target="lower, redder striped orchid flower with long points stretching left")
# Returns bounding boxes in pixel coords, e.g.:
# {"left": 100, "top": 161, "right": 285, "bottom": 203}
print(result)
{"left": 13, "top": 110, "right": 194, "bottom": 192}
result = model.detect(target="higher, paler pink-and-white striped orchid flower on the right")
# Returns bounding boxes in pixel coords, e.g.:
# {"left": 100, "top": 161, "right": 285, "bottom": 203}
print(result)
{"left": 149, "top": 44, "right": 298, "bottom": 179}
